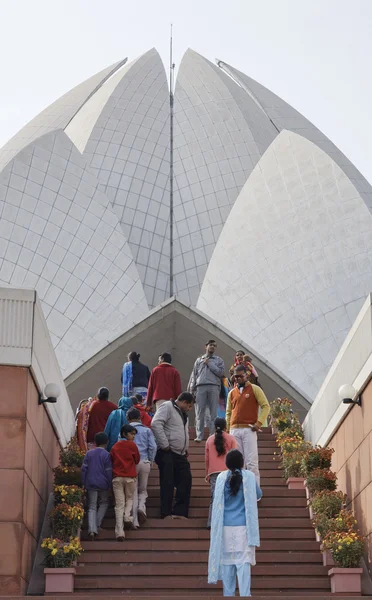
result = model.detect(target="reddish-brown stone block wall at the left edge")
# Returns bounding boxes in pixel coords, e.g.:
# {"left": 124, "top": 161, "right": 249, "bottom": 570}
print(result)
{"left": 0, "top": 365, "right": 59, "bottom": 595}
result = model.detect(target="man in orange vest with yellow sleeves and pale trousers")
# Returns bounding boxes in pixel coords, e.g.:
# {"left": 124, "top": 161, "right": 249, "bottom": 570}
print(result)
{"left": 226, "top": 365, "right": 270, "bottom": 485}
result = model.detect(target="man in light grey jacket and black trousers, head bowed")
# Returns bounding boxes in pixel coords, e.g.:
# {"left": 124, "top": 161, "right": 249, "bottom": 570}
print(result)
{"left": 151, "top": 392, "right": 195, "bottom": 519}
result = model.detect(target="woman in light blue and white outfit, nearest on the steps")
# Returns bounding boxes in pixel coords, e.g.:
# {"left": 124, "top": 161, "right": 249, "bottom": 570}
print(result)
{"left": 208, "top": 450, "right": 262, "bottom": 596}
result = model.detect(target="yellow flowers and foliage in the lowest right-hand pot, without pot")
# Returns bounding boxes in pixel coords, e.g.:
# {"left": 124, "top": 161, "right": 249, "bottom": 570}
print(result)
{"left": 323, "top": 529, "right": 364, "bottom": 569}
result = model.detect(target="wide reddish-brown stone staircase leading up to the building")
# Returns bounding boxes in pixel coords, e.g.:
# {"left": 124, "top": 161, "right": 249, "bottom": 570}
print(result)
{"left": 75, "top": 429, "right": 340, "bottom": 599}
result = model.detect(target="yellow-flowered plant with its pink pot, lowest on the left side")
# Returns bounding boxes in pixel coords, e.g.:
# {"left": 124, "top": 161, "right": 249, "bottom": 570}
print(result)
{"left": 41, "top": 537, "right": 83, "bottom": 594}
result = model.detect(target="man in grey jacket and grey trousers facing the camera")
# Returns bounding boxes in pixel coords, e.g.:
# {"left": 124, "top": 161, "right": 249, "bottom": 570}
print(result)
{"left": 188, "top": 340, "right": 225, "bottom": 442}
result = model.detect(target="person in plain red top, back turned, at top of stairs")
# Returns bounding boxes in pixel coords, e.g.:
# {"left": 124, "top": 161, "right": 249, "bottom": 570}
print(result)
{"left": 147, "top": 352, "right": 182, "bottom": 410}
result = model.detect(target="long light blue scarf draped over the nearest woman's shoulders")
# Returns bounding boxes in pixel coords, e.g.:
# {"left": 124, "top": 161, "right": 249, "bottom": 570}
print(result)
{"left": 208, "top": 471, "right": 260, "bottom": 583}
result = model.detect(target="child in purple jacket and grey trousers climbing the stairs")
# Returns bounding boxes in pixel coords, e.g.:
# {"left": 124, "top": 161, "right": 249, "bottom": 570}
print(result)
{"left": 81, "top": 433, "right": 112, "bottom": 540}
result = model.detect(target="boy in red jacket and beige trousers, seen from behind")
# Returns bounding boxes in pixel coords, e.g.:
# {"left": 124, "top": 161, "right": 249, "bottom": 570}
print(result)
{"left": 110, "top": 425, "right": 140, "bottom": 542}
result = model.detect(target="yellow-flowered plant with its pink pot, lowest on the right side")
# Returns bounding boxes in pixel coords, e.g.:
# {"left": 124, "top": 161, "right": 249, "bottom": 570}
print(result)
{"left": 323, "top": 529, "right": 364, "bottom": 594}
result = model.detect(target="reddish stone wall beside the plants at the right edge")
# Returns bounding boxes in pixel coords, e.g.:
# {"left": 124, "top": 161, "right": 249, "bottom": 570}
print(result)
{"left": 329, "top": 380, "right": 372, "bottom": 575}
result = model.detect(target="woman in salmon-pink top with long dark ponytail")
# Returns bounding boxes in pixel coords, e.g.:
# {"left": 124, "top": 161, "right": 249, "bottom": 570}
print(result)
{"left": 205, "top": 417, "right": 238, "bottom": 528}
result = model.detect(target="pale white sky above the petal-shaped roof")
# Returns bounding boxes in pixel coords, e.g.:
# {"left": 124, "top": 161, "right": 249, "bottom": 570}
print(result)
{"left": 0, "top": 0, "right": 372, "bottom": 183}
